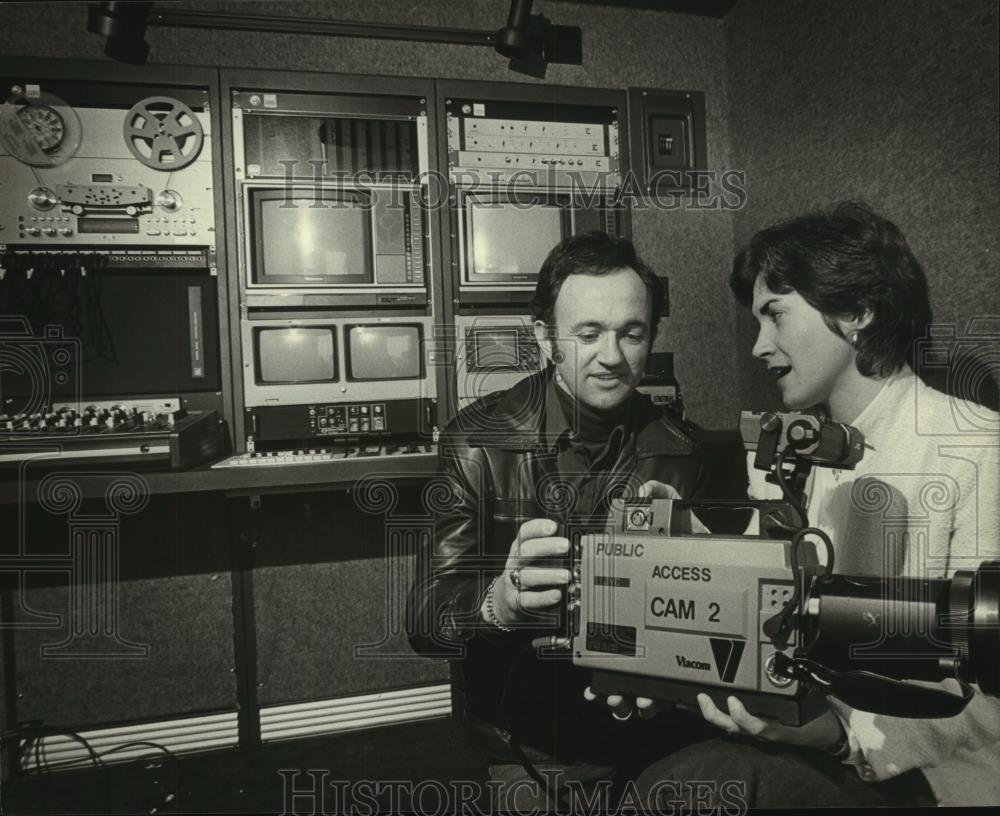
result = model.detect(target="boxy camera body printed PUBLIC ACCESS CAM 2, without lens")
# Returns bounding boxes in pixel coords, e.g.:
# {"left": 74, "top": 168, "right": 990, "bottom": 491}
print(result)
{"left": 569, "top": 499, "right": 822, "bottom": 725}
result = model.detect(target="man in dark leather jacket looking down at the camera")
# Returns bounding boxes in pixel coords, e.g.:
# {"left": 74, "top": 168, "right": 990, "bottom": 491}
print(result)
{"left": 410, "top": 232, "right": 705, "bottom": 809}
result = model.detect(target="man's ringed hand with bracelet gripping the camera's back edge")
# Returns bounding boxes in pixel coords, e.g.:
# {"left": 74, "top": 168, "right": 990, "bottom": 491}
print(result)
{"left": 482, "top": 519, "right": 569, "bottom": 627}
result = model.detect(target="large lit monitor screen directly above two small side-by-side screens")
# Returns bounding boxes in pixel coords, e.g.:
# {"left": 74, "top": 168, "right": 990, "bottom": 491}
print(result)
{"left": 258, "top": 196, "right": 369, "bottom": 283}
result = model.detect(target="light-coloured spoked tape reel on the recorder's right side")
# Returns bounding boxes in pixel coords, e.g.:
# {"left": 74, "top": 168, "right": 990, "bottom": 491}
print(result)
{"left": 122, "top": 96, "right": 205, "bottom": 171}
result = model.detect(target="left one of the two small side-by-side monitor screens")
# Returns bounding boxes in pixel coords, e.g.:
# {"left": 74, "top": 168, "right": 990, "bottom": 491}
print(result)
{"left": 257, "top": 327, "right": 337, "bottom": 384}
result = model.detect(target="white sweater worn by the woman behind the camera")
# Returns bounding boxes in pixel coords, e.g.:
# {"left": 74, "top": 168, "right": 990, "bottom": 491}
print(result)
{"left": 750, "top": 368, "right": 1000, "bottom": 805}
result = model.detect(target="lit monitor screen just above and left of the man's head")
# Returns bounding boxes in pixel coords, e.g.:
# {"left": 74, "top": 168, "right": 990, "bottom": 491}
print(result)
{"left": 469, "top": 201, "right": 563, "bottom": 277}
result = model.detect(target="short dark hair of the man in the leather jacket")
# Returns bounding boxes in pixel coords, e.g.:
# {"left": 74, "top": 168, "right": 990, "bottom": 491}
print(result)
{"left": 531, "top": 231, "right": 664, "bottom": 343}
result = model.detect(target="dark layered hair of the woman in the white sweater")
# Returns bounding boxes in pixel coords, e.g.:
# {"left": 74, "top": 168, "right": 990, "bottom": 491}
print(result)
{"left": 729, "top": 201, "right": 932, "bottom": 376}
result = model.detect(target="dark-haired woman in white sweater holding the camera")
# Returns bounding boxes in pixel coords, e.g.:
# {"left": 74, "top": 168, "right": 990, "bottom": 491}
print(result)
{"left": 628, "top": 202, "right": 1000, "bottom": 807}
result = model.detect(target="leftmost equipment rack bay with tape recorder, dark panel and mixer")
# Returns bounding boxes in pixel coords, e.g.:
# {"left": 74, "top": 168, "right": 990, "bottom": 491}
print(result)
{"left": 0, "top": 75, "right": 223, "bottom": 472}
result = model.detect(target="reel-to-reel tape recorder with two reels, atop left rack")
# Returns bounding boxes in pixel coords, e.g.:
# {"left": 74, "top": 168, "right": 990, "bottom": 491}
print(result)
{"left": 0, "top": 82, "right": 215, "bottom": 249}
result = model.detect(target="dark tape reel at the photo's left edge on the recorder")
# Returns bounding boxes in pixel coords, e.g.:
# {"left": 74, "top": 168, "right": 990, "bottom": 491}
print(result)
{"left": 0, "top": 89, "right": 83, "bottom": 167}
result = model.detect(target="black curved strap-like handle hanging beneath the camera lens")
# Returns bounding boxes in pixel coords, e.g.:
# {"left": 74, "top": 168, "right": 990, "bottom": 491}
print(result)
{"left": 774, "top": 650, "right": 975, "bottom": 719}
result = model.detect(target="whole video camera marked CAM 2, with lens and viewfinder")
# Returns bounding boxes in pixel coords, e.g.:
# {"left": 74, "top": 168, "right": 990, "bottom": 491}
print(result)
{"left": 568, "top": 413, "right": 1000, "bottom": 725}
